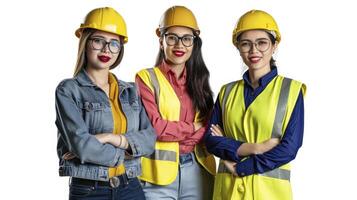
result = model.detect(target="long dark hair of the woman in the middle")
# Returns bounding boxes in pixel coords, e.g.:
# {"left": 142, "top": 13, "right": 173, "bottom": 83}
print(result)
{"left": 155, "top": 30, "right": 214, "bottom": 121}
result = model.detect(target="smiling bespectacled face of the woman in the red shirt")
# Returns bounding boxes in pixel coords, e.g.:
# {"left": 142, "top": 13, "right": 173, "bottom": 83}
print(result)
{"left": 160, "top": 26, "right": 194, "bottom": 65}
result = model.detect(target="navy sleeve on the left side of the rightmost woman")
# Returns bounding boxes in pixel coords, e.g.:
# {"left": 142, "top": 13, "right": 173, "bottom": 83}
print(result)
{"left": 204, "top": 97, "right": 243, "bottom": 162}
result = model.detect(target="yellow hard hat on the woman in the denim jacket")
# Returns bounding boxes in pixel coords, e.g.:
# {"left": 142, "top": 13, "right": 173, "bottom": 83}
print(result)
{"left": 76, "top": 7, "right": 128, "bottom": 43}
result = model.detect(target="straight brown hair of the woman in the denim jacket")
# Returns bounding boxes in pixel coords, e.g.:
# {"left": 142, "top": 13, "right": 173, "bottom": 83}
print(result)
{"left": 73, "top": 28, "right": 124, "bottom": 76}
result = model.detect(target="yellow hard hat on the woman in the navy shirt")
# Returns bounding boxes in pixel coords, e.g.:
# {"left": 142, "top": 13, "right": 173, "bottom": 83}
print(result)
{"left": 232, "top": 10, "right": 281, "bottom": 46}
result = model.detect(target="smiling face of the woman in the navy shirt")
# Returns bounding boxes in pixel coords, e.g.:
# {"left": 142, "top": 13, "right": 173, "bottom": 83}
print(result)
{"left": 238, "top": 30, "right": 277, "bottom": 71}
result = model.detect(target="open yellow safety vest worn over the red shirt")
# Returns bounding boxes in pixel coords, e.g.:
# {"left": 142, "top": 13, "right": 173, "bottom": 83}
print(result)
{"left": 137, "top": 67, "right": 216, "bottom": 185}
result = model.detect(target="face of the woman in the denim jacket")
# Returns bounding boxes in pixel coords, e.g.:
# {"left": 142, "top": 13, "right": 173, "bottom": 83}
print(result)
{"left": 86, "top": 31, "right": 121, "bottom": 69}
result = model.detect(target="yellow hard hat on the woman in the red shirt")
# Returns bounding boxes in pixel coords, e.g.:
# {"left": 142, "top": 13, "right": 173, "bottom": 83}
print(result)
{"left": 156, "top": 6, "right": 200, "bottom": 37}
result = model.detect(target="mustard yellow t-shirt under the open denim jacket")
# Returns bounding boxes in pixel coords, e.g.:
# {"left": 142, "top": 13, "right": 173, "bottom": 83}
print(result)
{"left": 109, "top": 73, "right": 126, "bottom": 177}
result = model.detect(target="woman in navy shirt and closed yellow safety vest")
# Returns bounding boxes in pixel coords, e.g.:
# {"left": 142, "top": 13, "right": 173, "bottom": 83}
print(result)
{"left": 205, "top": 10, "right": 306, "bottom": 200}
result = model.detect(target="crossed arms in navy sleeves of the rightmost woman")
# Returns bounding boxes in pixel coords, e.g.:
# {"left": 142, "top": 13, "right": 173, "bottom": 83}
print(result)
{"left": 205, "top": 92, "right": 304, "bottom": 176}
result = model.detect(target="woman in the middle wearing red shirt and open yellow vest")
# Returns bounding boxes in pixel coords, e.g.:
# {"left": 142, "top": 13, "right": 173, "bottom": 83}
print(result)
{"left": 136, "top": 6, "right": 216, "bottom": 200}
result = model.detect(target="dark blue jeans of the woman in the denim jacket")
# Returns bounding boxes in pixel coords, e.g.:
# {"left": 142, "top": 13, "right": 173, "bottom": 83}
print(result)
{"left": 69, "top": 178, "right": 145, "bottom": 200}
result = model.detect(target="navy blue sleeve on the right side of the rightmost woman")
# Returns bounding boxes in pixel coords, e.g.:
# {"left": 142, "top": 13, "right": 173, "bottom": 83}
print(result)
{"left": 236, "top": 91, "right": 304, "bottom": 176}
